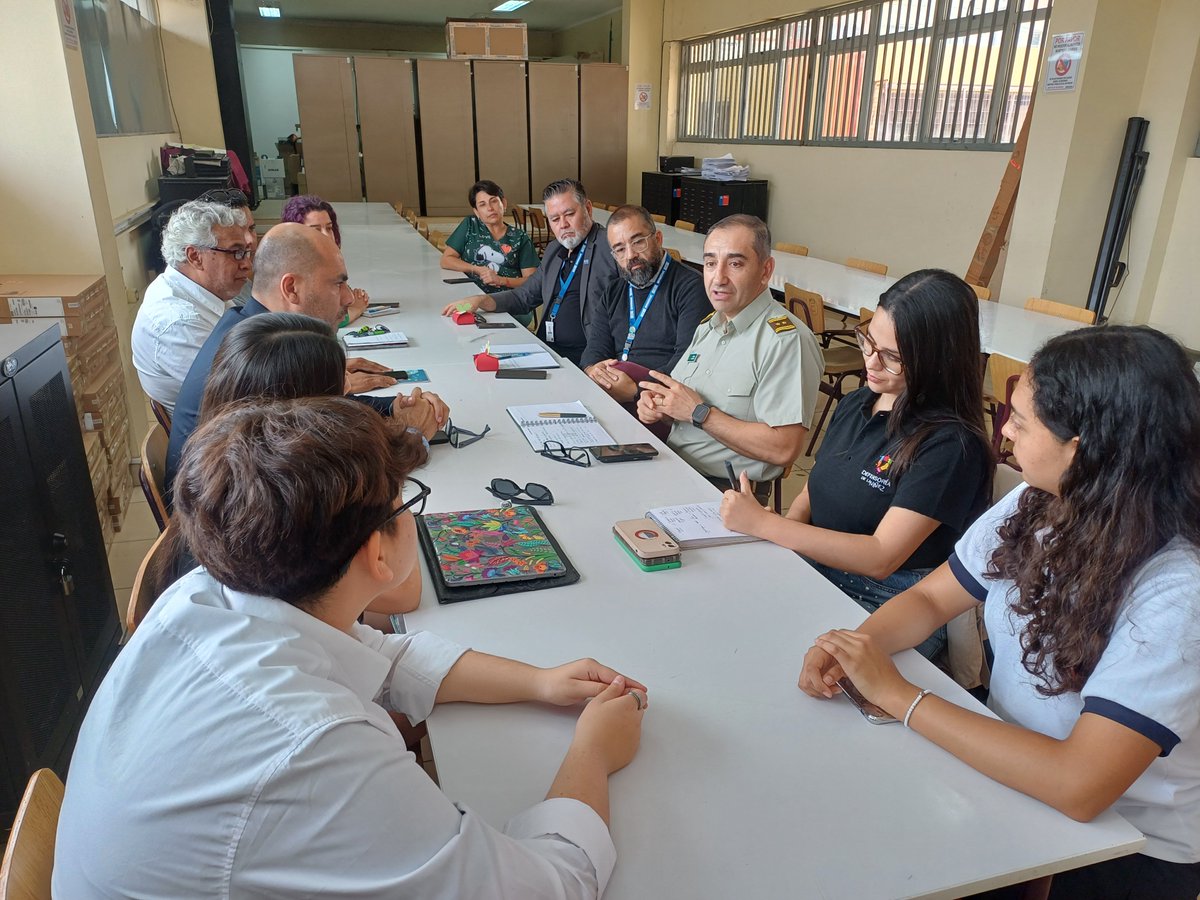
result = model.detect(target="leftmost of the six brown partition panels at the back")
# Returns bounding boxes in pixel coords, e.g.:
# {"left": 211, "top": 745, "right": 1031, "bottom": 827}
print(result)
{"left": 292, "top": 53, "right": 362, "bottom": 200}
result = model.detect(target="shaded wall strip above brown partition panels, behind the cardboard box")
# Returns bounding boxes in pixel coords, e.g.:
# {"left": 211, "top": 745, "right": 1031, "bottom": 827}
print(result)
{"left": 236, "top": 16, "right": 554, "bottom": 58}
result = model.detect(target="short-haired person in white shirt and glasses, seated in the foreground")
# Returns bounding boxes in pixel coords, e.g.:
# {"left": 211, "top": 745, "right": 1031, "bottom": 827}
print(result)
{"left": 53, "top": 397, "right": 647, "bottom": 900}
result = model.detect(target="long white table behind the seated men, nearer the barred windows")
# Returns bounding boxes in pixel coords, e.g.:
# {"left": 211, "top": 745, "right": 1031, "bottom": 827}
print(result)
{"left": 542, "top": 204, "right": 1081, "bottom": 362}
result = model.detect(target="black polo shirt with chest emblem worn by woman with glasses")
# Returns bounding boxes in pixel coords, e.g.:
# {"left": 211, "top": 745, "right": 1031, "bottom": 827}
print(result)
{"left": 809, "top": 386, "right": 991, "bottom": 569}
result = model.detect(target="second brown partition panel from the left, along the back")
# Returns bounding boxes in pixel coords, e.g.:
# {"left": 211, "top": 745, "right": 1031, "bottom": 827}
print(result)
{"left": 354, "top": 56, "right": 421, "bottom": 209}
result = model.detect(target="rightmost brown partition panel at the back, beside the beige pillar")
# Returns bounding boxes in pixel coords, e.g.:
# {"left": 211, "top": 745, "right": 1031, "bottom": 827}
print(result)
{"left": 580, "top": 64, "right": 629, "bottom": 204}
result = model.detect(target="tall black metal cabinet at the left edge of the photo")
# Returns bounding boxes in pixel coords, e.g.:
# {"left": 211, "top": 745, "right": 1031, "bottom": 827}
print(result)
{"left": 0, "top": 325, "right": 120, "bottom": 817}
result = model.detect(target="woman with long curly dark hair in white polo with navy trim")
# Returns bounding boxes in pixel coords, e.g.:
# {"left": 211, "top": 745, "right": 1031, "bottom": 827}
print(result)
{"left": 800, "top": 326, "right": 1200, "bottom": 900}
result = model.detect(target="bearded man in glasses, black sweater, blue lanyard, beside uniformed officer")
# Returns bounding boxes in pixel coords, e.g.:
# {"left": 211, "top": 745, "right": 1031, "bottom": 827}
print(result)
{"left": 580, "top": 206, "right": 713, "bottom": 415}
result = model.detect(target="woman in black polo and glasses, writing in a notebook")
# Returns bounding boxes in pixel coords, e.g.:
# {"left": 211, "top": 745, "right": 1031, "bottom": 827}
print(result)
{"left": 721, "top": 269, "right": 992, "bottom": 656}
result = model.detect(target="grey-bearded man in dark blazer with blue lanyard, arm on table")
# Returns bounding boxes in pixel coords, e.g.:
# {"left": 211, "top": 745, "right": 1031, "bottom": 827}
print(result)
{"left": 443, "top": 179, "right": 617, "bottom": 365}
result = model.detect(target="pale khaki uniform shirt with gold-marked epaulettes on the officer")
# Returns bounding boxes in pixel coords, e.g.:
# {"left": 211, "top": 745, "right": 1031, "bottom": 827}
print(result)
{"left": 667, "top": 290, "right": 824, "bottom": 481}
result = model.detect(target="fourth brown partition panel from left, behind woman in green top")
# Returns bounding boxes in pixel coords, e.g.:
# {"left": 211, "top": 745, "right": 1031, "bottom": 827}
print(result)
{"left": 474, "top": 60, "right": 530, "bottom": 205}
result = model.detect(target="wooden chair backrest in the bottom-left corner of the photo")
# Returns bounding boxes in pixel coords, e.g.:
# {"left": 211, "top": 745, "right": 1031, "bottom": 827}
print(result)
{"left": 0, "top": 769, "right": 65, "bottom": 900}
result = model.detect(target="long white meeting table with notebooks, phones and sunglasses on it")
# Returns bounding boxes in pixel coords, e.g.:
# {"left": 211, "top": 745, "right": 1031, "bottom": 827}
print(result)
{"left": 337, "top": 204, "right": 1142, "bottom": 900}
